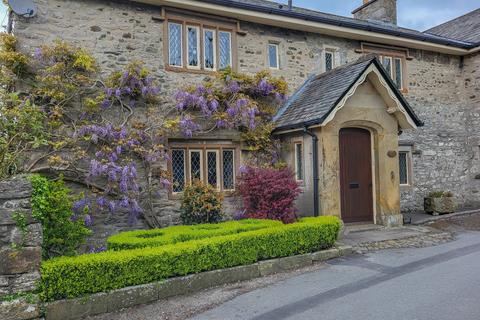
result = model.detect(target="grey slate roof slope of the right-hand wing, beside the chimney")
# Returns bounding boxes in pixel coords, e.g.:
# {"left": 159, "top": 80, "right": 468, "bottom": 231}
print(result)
{"left": 425, "top": 8, "right": 480, "bottom": 45}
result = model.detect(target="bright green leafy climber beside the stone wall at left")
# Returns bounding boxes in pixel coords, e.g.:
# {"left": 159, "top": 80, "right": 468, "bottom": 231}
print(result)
{"left": 31, "top": 175, "right": 91, "bottom": 259}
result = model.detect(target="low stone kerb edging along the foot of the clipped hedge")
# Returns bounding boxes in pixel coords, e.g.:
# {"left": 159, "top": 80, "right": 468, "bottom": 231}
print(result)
{"left": 44, "top": 245, "right": 353, "bottom": 320}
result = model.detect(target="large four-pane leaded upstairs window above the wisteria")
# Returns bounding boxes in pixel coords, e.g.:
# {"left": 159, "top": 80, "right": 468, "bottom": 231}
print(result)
{"left": 165, "top": 19, "right": 234, "bottom": 72}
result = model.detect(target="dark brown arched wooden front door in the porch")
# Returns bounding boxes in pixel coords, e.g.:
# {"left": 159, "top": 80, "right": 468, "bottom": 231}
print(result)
{"left": 340, "top": 128, "right": 373, "bottom": 222}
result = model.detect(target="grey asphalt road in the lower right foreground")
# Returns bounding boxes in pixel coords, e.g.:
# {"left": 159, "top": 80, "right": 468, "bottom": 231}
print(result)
{"left": 192, "top": 231, "right": 480, "bottom": 320}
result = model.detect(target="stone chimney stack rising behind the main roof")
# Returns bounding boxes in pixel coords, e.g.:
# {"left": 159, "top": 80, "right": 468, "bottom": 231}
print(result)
{"left": 352, "top": 0, "right": 397, "bottom": 25}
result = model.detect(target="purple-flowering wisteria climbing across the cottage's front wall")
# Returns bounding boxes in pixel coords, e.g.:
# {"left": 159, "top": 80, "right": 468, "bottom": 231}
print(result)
{"left": 0, "top": 34, "right": 287, "bottom": 226}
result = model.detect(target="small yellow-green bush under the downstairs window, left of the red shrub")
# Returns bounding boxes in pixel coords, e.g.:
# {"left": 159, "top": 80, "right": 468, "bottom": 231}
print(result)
{"left": 180, "top": 181, "right": 223, "bottom": 224}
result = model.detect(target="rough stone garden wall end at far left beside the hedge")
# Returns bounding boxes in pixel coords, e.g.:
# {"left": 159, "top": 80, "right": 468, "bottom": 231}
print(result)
{"left": 0, "top": 176, "right": 43, "bottom": 320}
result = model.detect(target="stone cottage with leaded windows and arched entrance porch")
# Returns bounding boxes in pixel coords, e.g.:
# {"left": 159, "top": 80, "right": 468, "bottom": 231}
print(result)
{"left": 10, "top": 0, "right": 480, "bottom": 232}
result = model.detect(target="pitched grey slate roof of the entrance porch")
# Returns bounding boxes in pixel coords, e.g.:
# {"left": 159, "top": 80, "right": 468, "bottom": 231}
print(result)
{"left": 273, "top": 55, "right": 423, "bottom": 131}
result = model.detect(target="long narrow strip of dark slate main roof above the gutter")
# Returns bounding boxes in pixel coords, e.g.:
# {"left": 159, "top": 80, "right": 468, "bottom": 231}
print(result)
{"left": 199, "top": 0, "right": 473, "bottom": 49}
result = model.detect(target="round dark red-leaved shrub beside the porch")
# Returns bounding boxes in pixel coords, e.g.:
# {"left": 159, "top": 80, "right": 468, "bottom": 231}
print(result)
{"left": 237, "top": 167, "right": 300, "bottom": 223}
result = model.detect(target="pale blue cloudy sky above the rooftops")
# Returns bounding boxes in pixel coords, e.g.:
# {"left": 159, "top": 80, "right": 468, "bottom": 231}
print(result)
{"left": 0, "top": 0, "right": 480, "bottom": 31}
